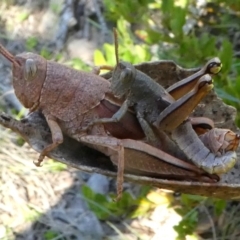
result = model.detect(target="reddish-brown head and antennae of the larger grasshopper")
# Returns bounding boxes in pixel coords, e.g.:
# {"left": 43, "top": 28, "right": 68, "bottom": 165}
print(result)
{"left": 0, "top": 45, "right": 47, "bottom": 110}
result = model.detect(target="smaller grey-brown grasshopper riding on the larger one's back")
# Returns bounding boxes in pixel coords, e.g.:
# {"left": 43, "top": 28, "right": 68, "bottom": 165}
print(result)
{"left": 87, "top": 29, "right": 239, "bottom": 174}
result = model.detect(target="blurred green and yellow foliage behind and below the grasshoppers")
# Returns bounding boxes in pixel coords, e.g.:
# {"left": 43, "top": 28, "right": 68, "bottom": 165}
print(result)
{"left": 0, "top": 0, "right": 240, "bottom": 239}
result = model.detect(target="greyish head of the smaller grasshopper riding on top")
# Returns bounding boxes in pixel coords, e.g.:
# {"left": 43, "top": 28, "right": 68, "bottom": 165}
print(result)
{"left": 111, "top": 62, "right": 136, "bottom": 97}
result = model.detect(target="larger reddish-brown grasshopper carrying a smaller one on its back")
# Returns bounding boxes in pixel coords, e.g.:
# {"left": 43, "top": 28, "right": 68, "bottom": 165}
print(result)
{"left": 0, "top": 40, "right": 225, "bottom": 200}
